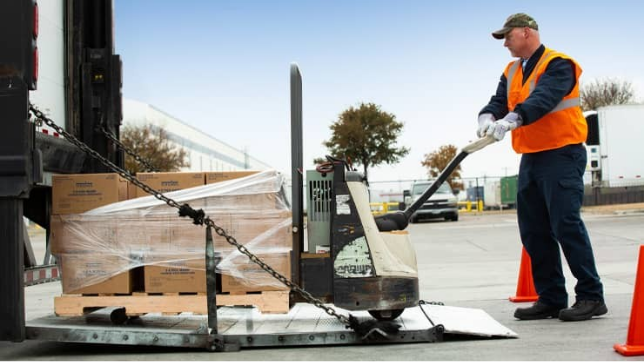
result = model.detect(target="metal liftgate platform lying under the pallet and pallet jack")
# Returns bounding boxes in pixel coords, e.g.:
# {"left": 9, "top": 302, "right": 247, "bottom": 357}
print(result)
{"left": 27, "top": 304, "right": 517, "bottom": 350}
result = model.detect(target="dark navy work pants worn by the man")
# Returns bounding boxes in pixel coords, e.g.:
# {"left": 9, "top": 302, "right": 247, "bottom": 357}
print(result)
{"left": 517, "top": 144, "right": 604, "bottom": 307}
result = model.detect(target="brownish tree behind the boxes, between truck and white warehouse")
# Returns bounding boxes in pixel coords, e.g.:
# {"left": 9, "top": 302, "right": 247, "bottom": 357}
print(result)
{"left": 121, "top": 124, "right": 190, "bottom": 174}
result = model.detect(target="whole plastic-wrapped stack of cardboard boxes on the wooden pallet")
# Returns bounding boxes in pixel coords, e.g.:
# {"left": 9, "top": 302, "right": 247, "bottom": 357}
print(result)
{"left": 51, "top": 171, "right": 292, "bottom": 294}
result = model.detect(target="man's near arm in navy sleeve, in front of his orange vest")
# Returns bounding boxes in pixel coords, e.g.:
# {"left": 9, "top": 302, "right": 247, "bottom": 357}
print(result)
{"left": 514, "top": 58, "right": 576, "bottom": 126}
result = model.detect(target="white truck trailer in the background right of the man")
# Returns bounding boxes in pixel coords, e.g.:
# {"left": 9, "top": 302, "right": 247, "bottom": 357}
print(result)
{"left": 584, "top": 104, "right": 644, "bottom": 187}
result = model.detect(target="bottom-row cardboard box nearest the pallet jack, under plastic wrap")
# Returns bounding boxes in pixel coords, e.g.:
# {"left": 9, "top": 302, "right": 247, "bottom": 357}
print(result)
{"left": 221, "top": 253, "right": 291, "bottom": 292}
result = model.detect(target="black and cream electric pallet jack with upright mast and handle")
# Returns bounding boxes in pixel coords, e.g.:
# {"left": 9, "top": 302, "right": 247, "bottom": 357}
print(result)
{"left": 291, "top": 65, "right": 495, "bottom": 321}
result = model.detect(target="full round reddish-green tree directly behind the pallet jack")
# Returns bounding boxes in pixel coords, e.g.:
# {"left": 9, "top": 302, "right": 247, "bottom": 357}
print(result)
{"left": 315, "top": 103, "right": 409, "bottom": 177}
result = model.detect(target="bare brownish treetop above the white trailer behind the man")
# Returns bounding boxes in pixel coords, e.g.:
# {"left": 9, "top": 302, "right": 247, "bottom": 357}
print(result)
{"left": 579, "top": 78, "right": 635, "bottom": 111}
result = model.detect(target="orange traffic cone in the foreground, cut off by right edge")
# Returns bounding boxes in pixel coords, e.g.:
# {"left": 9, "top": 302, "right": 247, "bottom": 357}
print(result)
{"left": 613, "top": 245, "right": 644, "bottom": 356}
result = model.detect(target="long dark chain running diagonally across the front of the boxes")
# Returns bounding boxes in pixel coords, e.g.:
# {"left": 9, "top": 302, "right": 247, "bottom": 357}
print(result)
{"left": 29, "top": 104, "right": 350, "bottom": 329}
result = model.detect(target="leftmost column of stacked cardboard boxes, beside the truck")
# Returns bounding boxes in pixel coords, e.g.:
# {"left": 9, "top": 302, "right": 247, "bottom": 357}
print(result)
{"left": 50, "top": 174, "right": 133, "bottom": 294}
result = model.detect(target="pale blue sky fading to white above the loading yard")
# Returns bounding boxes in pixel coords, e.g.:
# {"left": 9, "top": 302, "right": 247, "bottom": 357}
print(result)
{"left": 114, "top": 0, "right": 644, "bottom": 181}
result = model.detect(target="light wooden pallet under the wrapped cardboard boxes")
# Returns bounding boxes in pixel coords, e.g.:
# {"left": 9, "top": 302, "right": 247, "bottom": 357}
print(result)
{"left": 54, "top": 291, "right": 290, "bottom": 317}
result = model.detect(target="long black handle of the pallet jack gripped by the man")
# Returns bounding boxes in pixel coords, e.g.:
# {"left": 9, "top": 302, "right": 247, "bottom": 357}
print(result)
{"left": 375, "top": 135, "right": 496, "bottom": 231}
